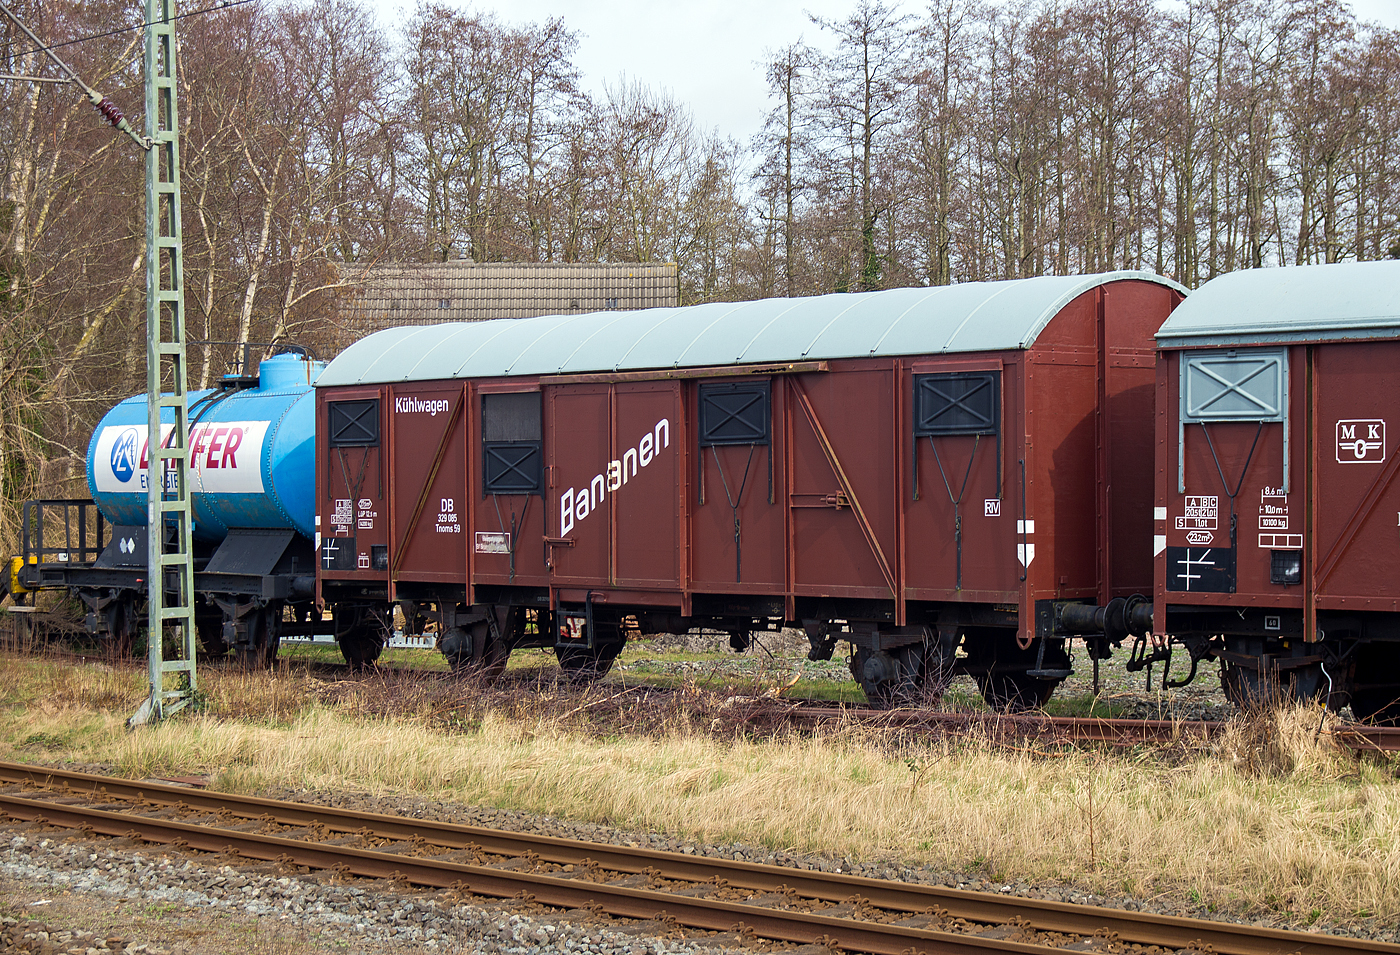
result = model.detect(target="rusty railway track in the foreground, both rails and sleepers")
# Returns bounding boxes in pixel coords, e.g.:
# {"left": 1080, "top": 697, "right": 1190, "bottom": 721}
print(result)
{"left": 0, "top": 763, "right": 1400, "bottom": 955}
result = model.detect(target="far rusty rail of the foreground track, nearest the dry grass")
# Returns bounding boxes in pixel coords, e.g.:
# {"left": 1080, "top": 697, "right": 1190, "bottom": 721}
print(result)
{"left": 0, "top": 762, "right": 1400, "bottom": 955}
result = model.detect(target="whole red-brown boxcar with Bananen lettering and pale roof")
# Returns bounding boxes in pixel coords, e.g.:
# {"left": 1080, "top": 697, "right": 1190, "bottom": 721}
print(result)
{"left": 316, "top": 272, "right": 1184, "bottom": 706}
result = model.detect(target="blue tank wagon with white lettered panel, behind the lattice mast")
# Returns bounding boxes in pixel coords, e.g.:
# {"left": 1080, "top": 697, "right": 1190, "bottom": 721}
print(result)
{"left": 10, "top": 353, "right": 325, "bottom": 665}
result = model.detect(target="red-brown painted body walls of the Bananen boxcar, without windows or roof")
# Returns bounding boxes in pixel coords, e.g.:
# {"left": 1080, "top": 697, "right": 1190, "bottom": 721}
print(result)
{"left": 318, "top": 280, "right": 1180, "bottom": 636}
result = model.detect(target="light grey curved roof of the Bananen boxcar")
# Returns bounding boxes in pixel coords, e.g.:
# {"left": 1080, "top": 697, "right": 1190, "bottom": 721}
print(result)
{"left": 316, "top": 272, "right": 1186, "bottom": 388}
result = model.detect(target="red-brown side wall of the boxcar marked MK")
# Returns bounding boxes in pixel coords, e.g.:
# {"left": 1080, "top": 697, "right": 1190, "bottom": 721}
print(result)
{"left": 1156, "top": 342, "right": 1400, "bottom": 639}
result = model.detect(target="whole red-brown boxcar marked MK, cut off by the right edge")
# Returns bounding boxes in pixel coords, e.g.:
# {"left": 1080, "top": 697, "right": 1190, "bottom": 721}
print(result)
{"left": 1154, "top": 262, "right": 1400, "bottom": 718}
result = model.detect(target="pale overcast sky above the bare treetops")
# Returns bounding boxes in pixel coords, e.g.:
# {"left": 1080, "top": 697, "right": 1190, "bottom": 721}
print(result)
{"left": 374, "top": 0, "right": 1400, "bottom": 144}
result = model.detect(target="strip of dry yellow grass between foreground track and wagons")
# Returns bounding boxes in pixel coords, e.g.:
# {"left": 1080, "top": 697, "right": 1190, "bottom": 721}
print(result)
{"left": 0, "top": 646, "right": 1400, "bottom": 920}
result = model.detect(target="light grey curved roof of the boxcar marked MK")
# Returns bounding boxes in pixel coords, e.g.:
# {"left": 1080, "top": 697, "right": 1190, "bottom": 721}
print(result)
{"left": 1156, "top": 260, "right": 1400, "bottom": 347}
